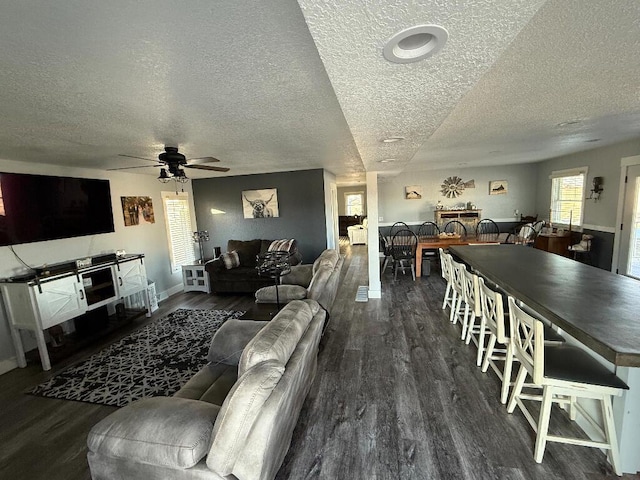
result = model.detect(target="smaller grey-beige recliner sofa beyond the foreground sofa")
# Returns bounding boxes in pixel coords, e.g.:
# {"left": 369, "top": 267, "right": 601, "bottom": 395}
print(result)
{"left": 255, "top": 249, "right": 344, "bottom": 311}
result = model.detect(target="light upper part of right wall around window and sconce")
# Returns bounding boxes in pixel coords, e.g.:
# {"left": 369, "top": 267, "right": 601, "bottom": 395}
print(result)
{"left": 536, "top": 140, "right": 640, "bottom": 230}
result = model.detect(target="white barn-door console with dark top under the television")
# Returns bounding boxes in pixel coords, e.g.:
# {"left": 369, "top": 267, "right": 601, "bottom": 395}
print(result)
{"left": 0, "top": 255, "right": 151, "bottom": 370}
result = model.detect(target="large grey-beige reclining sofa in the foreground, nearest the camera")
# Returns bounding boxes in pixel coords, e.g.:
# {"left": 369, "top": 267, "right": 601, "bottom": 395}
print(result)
{"left": 87, "top": 300, "right": 326, "bottom": 480}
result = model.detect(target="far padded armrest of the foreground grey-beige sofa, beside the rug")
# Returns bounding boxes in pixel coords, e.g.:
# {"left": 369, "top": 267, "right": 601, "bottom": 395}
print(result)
{"left": 207, "top": 319, "right": 269, "bottom": 365}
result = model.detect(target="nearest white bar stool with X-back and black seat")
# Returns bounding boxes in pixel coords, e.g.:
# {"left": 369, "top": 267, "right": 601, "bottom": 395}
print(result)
{"left": 507, "top": 296, "right": 629, "bottom": 475}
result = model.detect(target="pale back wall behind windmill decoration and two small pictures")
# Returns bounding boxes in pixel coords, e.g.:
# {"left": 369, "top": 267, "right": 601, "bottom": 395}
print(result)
{"left": 378, "top": 164, "right": 538, "bottom": 225}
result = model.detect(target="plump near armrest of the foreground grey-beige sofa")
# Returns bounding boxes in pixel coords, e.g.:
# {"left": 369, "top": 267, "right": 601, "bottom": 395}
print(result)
{"left": 87, "top": 397, "right": 220, "bottom": 468}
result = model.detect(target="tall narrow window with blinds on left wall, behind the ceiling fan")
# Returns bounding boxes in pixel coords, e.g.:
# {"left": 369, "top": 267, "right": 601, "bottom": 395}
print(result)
{"left": 162, "top": 192, "right": 196, "bottom": 271}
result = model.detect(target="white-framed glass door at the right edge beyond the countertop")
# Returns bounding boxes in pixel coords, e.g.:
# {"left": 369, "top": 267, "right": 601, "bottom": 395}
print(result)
{"left": 618, "top": 165, "right": 640, "bottom": 279}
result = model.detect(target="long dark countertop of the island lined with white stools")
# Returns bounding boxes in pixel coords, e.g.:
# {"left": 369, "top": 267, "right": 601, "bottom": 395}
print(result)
{"left": 449, "top": 245, "right": 640, "bottom": 367}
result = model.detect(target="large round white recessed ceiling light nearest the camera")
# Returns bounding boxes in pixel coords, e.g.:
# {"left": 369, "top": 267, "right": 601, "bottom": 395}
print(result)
{"left": 382, "top": 25, "right": 449, "bottom": 63}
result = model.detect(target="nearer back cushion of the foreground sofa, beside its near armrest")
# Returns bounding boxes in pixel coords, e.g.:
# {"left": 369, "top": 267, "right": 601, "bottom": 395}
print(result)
{"left": 207, "top": 361, "right": 284, "bottom": 476}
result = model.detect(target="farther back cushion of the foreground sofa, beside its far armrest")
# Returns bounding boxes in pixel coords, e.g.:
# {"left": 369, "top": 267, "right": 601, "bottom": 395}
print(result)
{"left": 238, "top": 300, "right": 313, "bottom": 375}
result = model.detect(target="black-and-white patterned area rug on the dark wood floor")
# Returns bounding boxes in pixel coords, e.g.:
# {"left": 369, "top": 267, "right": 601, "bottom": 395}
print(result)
{"left": 28, "top": 309, "right": 244, "bottom": 407}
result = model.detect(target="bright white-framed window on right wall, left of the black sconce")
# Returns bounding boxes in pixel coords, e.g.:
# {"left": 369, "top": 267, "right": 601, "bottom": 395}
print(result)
{"left": 549, "top": 167, "right": 587, "bottom": 225}
